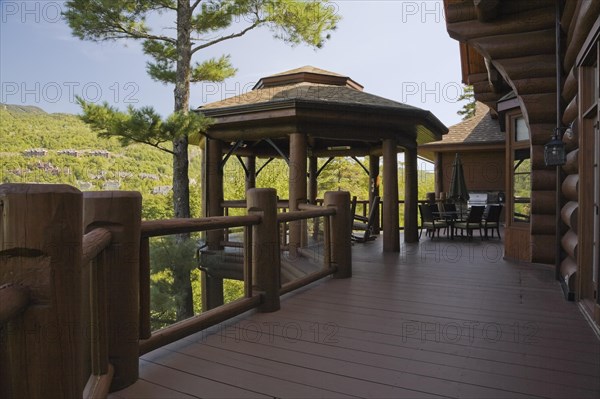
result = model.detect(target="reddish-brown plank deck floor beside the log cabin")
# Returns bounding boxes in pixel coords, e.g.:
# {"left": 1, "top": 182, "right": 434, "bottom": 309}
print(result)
{"left": 111, "top": 238, "right": 600, "bottom": 399}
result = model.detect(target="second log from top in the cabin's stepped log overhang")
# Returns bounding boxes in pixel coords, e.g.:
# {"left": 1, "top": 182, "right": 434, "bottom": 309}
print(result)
{"left": 446, "top": 2, "right": 555, "bottom": 42}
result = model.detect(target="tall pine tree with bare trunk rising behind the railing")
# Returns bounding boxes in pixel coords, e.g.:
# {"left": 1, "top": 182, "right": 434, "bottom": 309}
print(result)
{"left": 64, "top": 0, "right": 339, "bottom": 319}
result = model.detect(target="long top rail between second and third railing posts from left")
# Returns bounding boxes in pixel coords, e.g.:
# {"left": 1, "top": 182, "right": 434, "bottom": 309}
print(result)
{"left": 141, "top": 215, "right": 261, "bottom": 237}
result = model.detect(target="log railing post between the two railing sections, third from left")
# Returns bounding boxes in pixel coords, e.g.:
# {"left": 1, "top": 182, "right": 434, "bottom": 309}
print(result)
{"left": 246, "top": 188, "right": 281, "bottom": 312}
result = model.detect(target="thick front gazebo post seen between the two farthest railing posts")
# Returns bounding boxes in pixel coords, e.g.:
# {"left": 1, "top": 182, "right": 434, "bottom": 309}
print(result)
{"left": 289, "top": 133, "right": 306, "bottom": 257}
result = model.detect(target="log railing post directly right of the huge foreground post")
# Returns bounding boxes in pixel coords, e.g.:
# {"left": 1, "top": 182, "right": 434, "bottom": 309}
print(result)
{"left": 83, "top": 191, "right": 142, "bottom": 391}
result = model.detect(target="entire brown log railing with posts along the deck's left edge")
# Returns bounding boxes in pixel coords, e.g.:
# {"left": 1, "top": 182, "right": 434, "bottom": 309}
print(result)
{"left": 0, "top": 184, "right": 351, "bottom": 398}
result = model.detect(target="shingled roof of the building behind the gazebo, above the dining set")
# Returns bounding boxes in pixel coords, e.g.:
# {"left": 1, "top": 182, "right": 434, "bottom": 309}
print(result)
{"left": 422, "top": 102, "right": 504, "bottom": 151}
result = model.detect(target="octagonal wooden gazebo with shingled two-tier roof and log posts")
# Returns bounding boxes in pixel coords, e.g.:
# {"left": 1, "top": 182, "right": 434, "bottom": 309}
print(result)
{"left": 198, "top": 66, "right": 448, "bottom": 251}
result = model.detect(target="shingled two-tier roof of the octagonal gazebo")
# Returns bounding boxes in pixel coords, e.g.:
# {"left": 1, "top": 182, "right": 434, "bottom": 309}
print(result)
{"left": 198, "top": 66, "right": 447, "bottom": 155}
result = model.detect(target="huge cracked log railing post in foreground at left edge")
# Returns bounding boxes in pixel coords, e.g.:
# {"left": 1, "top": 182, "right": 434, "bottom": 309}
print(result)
{"left": 0, "top": 184, "right": 84, "bottom": 398}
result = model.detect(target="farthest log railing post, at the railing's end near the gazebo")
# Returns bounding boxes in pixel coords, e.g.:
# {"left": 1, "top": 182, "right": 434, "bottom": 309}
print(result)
{"left": 324, "top": 191, "right": 352, "bottom": 278}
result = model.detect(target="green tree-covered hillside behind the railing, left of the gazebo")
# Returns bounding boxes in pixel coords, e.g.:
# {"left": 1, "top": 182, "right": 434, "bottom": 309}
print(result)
{"left": 0, "top": 104, "right": 200, "bottom": 218}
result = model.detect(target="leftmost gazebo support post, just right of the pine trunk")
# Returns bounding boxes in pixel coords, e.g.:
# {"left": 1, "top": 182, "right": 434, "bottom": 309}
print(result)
{"left": 202, "top": 139, "right": 224, "bottom": 311}
